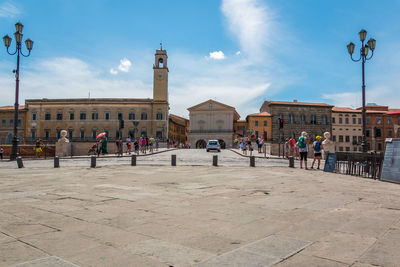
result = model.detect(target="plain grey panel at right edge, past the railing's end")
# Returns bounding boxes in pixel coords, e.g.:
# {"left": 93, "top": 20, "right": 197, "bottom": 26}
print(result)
{"left": 381, "top": 139, "right": 400, "bottom": 183}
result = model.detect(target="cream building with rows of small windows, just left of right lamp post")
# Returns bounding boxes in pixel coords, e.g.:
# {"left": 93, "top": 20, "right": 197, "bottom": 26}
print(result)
{"left": 332, "top": 107, "right": 362, "bottom": 152}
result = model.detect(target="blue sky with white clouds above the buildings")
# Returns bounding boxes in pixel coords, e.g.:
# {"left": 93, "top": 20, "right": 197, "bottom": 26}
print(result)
{"left": 0, "top": 0, "right": 400, "bottom": 119}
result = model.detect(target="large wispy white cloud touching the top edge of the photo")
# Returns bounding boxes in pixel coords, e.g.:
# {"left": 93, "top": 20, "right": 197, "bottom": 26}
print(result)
{"left": 221, "top": 0, "right": 273, "bottom": 59}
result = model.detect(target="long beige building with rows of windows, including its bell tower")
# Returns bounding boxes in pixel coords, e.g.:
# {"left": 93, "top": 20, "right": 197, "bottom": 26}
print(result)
{"left": 25, "top": 49, "right": 169, "bottom": 141}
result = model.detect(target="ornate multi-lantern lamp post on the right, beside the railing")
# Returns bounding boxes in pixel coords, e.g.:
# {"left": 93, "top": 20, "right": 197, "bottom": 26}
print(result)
{"left": 347, "top": 30, "right": 376, "bottom": 153}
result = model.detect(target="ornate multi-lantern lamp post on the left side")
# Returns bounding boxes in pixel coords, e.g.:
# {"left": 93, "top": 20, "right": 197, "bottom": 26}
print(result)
{"left": 3, "top": 22, "right": 33, "bottom": 160}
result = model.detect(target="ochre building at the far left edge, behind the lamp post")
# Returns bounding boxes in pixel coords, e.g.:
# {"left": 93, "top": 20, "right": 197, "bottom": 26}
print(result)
{"left": 0, "top": 106, "right": 27, "bottom": 145}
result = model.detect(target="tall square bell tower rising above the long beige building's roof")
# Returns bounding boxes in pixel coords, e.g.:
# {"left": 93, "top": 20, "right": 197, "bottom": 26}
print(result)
{"left": 153, "top": 45, "right": 169, "bottom": 102}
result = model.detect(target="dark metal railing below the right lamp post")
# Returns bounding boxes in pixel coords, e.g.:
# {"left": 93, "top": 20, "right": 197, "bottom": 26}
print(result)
{"left": 335, "top": 152, "right": 384, "bottom": 179}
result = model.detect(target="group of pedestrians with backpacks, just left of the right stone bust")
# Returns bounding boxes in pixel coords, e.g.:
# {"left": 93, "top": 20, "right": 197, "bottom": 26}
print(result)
{"left": 285, "top": 132, "right": 324, "bottom": 170}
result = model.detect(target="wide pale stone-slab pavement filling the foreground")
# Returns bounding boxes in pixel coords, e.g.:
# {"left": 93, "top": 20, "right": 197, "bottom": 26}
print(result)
{"left": 0, "top": 152, "right": 400, "bottom": 267}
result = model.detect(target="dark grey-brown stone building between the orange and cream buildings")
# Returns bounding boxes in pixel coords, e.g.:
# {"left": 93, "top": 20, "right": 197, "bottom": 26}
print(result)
{"left": 260, "top": 100, "right": 333, "bottom": 143}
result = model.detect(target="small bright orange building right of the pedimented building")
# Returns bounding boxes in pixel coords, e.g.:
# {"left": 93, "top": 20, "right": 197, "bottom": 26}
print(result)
{"left": 246, "top": 112, "right": 272, "bottom": 141}
